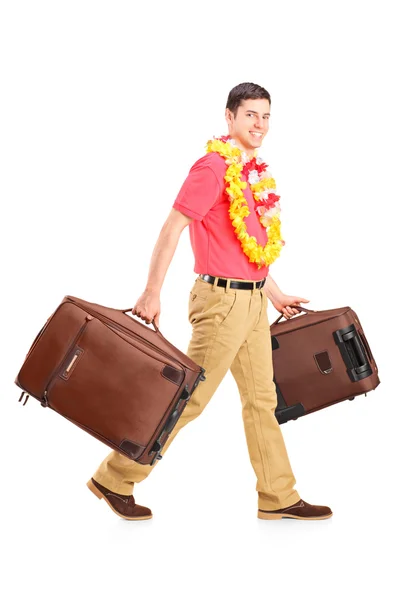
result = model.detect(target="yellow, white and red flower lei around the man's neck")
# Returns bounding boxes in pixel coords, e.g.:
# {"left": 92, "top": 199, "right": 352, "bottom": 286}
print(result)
{"left": 206, "top": 136, "right": 285, "bottom": 269}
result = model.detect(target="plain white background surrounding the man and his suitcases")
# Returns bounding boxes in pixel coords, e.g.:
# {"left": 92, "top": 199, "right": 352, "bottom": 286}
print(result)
{"left": 0, "top": 0, "right": 400, "bottom": 600}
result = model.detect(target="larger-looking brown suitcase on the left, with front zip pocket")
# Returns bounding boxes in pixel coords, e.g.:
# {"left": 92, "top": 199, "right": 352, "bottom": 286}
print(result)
{"left": 15, "top": 296, "right": 205, "bottom": 464}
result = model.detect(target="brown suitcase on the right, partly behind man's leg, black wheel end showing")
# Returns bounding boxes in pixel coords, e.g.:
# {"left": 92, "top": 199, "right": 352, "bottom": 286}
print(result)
{"left": 270, "top": 305, "right": 380, "bottom": 424}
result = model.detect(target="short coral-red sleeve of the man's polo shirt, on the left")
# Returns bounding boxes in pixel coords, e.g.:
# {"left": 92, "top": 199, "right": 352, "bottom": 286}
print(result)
{"left": 172, "top": 159, "right": 221, "bottom": 221}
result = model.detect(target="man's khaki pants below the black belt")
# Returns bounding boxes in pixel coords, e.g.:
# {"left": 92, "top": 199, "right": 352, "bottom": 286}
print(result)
{"left": 93, "top": 277, "right": 300, "bottom": 510}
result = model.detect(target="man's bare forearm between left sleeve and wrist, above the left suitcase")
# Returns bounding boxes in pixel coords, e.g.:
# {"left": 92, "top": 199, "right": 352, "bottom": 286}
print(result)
{"left": 146, "top": 223, "right": 181, "bottom": 293}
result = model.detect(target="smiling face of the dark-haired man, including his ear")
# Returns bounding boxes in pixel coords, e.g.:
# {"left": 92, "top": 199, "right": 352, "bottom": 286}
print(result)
{"left": 225, "top": 98, "right": 270, "bottom": 154}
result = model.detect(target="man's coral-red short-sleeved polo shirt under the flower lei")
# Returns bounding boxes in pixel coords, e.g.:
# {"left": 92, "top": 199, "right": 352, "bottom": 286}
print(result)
{"left": 172, "top": 152, "right": 269, "bottom": 281}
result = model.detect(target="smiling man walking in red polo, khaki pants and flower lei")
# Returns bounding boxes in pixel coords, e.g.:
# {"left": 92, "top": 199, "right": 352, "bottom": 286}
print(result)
{"left": 87, "top": 83, "right": 332, "bottom": 520}
